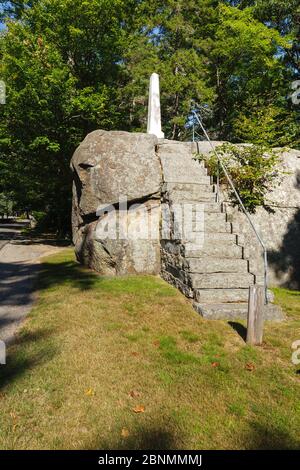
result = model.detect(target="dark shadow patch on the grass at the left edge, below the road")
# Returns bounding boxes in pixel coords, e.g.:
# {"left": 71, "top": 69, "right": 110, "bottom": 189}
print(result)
{"left": 0, "top": 329, "right": 57, "bottom": 390}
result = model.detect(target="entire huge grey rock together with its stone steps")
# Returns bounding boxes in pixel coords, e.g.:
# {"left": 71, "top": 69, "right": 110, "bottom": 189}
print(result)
{"left": 71, "top": 131, "right": 300, "bottom": 319}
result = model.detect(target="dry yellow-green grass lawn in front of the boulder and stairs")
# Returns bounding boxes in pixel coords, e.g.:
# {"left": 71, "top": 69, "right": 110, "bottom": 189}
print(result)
{"left": 0, "top": 249, "right": 300, "bottom": 449}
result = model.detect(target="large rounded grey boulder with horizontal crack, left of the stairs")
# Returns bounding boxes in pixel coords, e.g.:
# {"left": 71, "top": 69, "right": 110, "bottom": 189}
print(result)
{"left": 71, "top": 130, "right": 162, "bottom": 275}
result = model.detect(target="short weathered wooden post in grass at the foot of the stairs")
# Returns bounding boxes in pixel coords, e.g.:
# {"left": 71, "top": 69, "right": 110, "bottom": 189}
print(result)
{"left": 246, "top": 286, "right": 265, "bottom": 345}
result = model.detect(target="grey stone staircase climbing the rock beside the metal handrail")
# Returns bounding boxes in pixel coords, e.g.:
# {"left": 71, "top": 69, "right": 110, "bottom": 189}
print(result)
{"left": 158, "top": 140, "right": 282, "bottom": 319}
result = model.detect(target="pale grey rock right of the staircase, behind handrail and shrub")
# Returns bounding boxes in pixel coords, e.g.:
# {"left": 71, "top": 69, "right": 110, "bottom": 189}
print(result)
{"left": 195, "top": 142, "right": 300, "bottom": 289}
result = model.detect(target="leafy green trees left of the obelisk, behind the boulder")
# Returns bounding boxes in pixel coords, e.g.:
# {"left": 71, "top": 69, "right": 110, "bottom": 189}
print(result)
{"left": 0, "top": 0, "right": 131, "bottom": 233}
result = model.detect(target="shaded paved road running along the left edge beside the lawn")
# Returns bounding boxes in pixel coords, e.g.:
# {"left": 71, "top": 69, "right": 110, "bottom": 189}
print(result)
{"left": 0, "top": 220, "right": 64, "bottom": 344}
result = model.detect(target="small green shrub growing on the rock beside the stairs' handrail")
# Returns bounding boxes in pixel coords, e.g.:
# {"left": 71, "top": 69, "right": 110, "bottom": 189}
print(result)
{"left": 197, "top": 143, "right": 280, "bottom": 212}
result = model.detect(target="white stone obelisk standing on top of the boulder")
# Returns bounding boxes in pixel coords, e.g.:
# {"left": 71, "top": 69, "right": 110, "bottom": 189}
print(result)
{"left": 147, "top": 73, "right": 165, "bottom": 139}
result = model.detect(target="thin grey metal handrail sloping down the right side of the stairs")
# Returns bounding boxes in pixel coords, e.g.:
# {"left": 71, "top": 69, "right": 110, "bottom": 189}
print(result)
{"left": 192, "top": 110, "right": 269, "bottom": 304}
